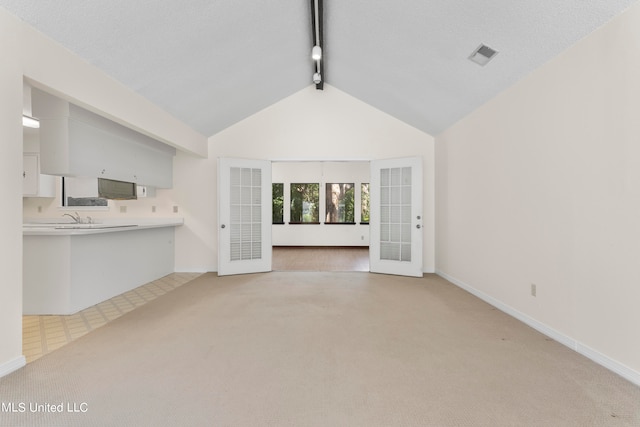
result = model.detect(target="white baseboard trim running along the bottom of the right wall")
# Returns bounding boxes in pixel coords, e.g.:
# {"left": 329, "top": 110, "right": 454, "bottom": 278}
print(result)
{"left": 436, "top": 269, "right": 640, "bottom": 386}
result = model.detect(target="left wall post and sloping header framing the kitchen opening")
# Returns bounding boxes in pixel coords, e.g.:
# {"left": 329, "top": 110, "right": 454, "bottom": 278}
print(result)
{"left": 0, "top": 8, "right": 207, "bottom": 376}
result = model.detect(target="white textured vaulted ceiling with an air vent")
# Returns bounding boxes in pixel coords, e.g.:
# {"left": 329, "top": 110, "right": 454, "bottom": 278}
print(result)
{"left": 0, "top": 0, "right": 637, "bottom": 136}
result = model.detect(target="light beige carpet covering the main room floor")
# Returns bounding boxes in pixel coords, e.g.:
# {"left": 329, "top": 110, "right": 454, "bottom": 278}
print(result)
{"left": 0, "top": 272, "right": 640, "bottom": 427}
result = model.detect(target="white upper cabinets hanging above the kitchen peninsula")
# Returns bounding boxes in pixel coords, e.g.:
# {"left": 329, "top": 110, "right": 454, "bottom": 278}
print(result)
{"left": 32, "top": 89, "right": 175, "bottom": 188}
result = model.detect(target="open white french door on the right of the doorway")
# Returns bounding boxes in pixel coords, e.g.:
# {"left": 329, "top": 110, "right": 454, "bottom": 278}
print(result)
{"left": 369, "top": 157, "right": 423, "bottom": 277}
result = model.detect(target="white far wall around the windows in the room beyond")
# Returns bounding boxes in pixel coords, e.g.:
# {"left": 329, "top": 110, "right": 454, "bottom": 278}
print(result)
{"left": 271, "top": 161, "right": 370, "bottom": 246}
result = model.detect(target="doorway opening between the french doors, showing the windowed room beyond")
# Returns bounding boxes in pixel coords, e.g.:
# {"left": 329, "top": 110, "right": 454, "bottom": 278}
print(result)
{"left": 271, "top": 160, "right": 370, "bottom": 272}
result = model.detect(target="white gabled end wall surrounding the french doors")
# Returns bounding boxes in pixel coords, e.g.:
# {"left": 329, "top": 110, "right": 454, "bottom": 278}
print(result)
{"left": 171, "top": 85, "right": 435, "bottom": 271}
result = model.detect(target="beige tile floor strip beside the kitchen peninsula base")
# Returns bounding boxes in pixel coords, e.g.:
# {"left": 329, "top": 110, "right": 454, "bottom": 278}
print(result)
{"left": 22, "top": 273, "right": 200, "bottom": 363}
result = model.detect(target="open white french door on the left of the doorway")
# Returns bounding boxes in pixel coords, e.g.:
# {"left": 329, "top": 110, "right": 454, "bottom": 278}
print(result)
{"left": 218, "top": 158, "right": 272, "bottom": 276}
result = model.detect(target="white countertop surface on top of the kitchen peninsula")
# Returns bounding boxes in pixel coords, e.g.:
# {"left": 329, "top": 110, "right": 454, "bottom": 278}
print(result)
{"left": 22, "top": 218, "right": 184, "bottom": 236}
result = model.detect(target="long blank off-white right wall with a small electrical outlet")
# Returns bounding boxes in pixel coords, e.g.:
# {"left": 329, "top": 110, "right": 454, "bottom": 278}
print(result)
{"left": 436, "top": 4, "right": 640, "bottom": 383}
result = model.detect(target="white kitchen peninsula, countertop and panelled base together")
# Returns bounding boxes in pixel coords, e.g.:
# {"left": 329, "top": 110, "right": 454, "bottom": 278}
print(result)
{"left": 22, "top": 218, "right": 183, "bottom": 315}
